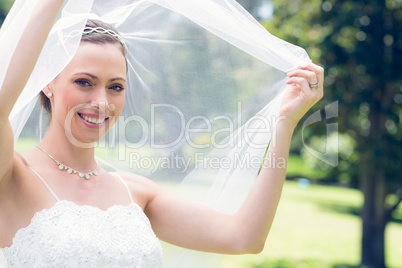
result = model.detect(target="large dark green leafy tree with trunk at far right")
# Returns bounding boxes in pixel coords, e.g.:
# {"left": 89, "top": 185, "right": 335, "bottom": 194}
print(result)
{"left": 265, "top": 0, "right": 402, "bottom": 267}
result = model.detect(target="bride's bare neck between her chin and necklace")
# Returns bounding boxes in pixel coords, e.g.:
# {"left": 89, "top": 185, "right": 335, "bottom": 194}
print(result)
{"left": 39, "top": 121, "right": 96, "bottom": 172}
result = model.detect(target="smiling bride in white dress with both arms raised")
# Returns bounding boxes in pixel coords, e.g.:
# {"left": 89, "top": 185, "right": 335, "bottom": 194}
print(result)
{"left": 0, "top": 0, "right": 323, "bottom": 267}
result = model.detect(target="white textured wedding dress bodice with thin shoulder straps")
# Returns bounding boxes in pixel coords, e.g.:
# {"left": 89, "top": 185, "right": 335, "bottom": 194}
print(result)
{"left": 0, "top": 169, "right": 162, "bottom": 268}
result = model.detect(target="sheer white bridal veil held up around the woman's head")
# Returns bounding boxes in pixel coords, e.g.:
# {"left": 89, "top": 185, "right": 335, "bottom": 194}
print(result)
{"left": 0, "top": 0, "right": 310, "bottom": 267}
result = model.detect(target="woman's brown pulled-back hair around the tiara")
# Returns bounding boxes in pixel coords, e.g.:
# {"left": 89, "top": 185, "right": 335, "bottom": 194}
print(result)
{"left": 40, "top": 19, "right": 127, "bottom": 113}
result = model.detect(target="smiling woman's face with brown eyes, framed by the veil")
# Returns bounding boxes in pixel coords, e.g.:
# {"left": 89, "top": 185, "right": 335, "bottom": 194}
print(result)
{"left": 49, "top": 42, "right": 126, "bottom": 145}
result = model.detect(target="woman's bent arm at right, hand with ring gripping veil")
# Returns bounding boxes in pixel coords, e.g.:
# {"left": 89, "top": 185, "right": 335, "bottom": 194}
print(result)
{"left": 145, "top": 64, "right": 324, "bottom": 254}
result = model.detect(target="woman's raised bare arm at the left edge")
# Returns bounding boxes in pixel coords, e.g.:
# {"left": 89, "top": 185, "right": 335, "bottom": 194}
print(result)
{"left": 0, "top": 0, "right": 64, "bottom": 184}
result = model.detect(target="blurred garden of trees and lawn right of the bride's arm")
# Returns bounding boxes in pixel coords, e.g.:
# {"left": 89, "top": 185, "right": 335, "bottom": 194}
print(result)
{"left": 0, "top": 0, "right": 402, "bottom": 268}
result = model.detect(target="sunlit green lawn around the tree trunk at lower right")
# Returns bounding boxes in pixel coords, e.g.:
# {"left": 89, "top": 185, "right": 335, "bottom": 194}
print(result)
{"left": 220, "top": 182, "right": 402, "bottom": 268}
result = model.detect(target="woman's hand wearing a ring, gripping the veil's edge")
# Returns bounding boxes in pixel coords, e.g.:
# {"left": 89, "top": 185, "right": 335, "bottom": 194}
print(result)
{"left": 280, "top": 63, "right": 324, "bottom": 127}
